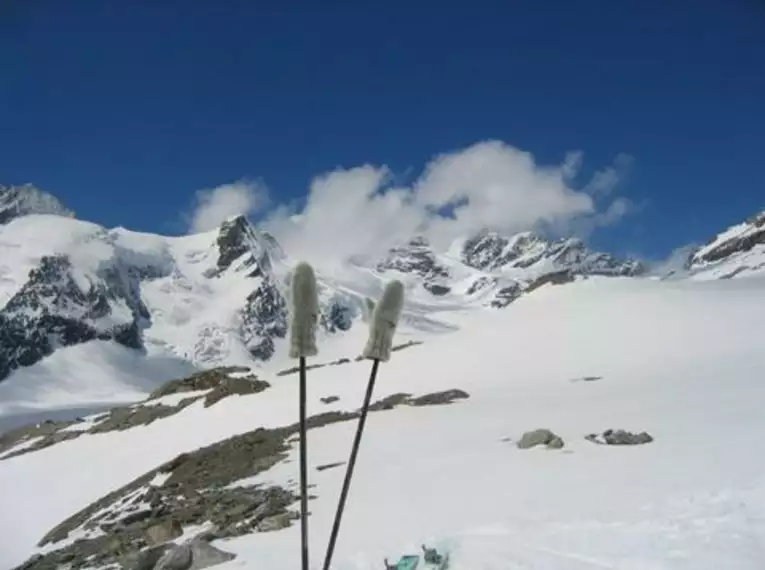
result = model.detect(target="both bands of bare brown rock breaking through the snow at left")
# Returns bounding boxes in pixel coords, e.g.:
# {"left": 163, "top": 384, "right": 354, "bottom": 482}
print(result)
{"left": 0, "top": 360, "right": 469, "bottom": 570}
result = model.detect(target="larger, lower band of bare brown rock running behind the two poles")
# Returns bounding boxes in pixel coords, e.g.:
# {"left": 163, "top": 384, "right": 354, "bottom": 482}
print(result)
{"left": 17, "top": 384, "right": 467, "bottom": 570}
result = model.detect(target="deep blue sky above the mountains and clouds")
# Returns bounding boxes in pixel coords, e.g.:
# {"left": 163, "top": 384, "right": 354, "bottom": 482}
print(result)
{"left": 0, "top": 0, "right": 765, "bottom": 258}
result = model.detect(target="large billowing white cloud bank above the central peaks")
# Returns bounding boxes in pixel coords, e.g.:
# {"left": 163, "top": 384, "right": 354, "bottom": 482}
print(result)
{"left": 263, "top": 141, "right": 630, "bottom": 263}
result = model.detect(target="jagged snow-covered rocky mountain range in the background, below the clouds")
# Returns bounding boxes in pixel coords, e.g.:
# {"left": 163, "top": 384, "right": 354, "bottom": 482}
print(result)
{"left": 0, "top": 186, "right": 765, "bottom": 381}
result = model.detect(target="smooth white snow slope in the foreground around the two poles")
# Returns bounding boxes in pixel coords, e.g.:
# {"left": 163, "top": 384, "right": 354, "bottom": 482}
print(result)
{"left": 0, "top": 272, "right": 765, "bottom": 570}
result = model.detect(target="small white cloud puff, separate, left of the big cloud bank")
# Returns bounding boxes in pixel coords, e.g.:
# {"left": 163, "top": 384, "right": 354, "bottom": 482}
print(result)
{"left": 187, "top": 182, "right": 268, "bottom": 233}
